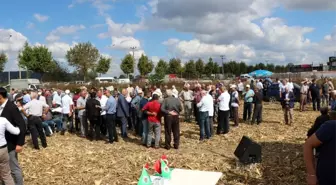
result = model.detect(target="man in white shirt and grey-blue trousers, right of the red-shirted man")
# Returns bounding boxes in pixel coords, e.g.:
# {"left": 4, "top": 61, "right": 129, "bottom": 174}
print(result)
{"left": 197, "top": 90, "right": 213, "bottom": 141}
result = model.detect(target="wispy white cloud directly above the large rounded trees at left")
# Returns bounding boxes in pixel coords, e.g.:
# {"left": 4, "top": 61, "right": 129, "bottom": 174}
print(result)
{"left": 46, "top": 25, "right": 85, "bottom": 42}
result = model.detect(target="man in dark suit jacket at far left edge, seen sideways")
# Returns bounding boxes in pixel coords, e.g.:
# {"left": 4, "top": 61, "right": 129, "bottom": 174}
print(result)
{"left": 0, "top": 87, "right": 26, "bottom": 185}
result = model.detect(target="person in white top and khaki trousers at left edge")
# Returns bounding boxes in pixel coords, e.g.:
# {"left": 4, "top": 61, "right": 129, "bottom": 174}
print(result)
{"left": 0, "top": 117, "right": 20, "bottom": 185}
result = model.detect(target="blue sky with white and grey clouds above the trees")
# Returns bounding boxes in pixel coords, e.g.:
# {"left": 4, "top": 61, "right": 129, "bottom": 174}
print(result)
{"left": 0, "top": 0, "right": 336, "bottom": 76}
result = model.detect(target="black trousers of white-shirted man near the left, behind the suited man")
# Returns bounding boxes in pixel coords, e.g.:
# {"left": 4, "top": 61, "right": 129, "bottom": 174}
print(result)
{"left": 28, "top": 116, "right": 47, "bottom": 149}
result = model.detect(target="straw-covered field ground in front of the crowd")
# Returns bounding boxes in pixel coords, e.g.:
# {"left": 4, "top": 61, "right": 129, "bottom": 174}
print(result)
{"left": 19, "top": 104, "right": 319, "bottom": 185}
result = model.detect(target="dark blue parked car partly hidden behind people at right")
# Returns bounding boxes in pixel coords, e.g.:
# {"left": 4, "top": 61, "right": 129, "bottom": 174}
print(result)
{"left": 264, "top": 83, "right": 301, "bottom": 102}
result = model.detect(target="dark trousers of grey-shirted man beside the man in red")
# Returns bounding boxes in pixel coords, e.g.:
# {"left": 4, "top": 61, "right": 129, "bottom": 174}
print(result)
{"left": 164, "top": 115, "right": 180, "bottom": 149}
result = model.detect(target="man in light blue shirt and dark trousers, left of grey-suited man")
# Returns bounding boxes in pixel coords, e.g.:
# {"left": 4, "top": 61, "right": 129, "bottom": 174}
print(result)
{"left": 103, "top": 90, "right": 118, "bottom": 144}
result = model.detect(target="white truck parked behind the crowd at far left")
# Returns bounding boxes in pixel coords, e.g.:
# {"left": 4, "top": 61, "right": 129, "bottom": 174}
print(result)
{"left": 10, "top": 78, "right": 42, "bottom": 90}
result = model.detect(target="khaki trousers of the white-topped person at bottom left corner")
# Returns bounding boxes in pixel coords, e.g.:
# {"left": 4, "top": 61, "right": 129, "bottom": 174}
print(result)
{"left": 0, "top": 147, "right": 15, "bottom": 185}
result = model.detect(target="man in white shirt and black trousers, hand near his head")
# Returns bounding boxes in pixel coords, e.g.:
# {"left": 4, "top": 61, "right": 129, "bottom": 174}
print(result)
{"left": 217, "top": 86, "right": 231, "bottom": 134}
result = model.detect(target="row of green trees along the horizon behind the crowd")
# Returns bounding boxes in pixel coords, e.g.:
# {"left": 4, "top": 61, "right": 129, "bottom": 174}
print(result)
{"left": 0, "top": 42, "right": 289, "bottom": 82}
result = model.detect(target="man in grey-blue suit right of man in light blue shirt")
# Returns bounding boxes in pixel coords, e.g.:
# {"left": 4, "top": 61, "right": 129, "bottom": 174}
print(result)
{"left": 117, "top": 89, "right": 129, "bottom": 138}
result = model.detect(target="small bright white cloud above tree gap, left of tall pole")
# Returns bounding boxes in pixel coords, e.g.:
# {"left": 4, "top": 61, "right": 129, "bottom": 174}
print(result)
{"left": 112, "top": 36, "right": 141, "bottom": 50}
